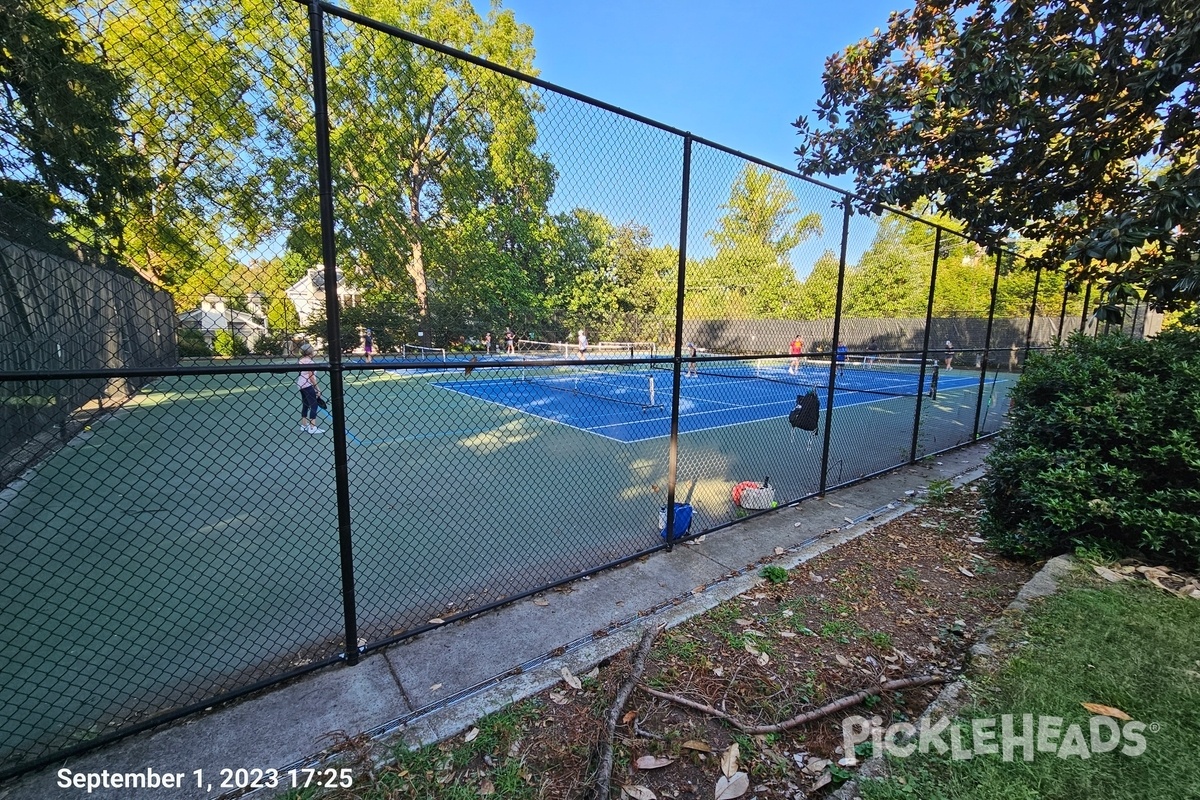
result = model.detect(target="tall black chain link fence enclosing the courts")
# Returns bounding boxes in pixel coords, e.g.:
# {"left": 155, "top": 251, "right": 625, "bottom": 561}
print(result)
{"left": 0, "top": 0, "right": 1153, "bottom": 777}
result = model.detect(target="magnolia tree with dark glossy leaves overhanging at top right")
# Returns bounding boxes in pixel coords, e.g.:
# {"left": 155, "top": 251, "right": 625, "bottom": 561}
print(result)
{"left": 794, "top": 0, "right": 1200, "bottom": 319}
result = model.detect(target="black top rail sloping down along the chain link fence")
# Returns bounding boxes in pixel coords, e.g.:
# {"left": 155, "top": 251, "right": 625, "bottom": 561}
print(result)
{"left": 302, "top": 0, "right": 1020, "bottom": 257}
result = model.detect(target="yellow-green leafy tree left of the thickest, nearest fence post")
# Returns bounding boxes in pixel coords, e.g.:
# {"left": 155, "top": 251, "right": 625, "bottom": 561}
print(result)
{"left": 44, "top": 0, "right": 294, "bottom": 289}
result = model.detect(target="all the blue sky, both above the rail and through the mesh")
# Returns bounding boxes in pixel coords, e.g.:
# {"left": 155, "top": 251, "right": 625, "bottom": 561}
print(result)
{"left": 475, "top": 0, "right": 908, "bottom": 272}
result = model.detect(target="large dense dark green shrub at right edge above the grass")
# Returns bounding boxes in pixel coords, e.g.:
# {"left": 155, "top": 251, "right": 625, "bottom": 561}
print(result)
{"left": 984, "top": 330, "right": 1200, "bottom": 569}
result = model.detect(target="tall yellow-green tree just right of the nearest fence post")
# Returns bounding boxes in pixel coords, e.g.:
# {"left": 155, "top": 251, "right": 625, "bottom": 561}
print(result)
{"left": 329, "top": 0, "right": 554, "bottom": 335}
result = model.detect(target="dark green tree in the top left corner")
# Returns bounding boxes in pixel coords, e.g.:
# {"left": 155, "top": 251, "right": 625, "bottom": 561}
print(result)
{"left": 0, "top": 0, "right": 150, "bottom": 254}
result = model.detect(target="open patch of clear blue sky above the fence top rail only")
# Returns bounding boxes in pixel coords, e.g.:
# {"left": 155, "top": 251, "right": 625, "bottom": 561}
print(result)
{"left": 487, "top": 0, "right": 911, "bottom": 176}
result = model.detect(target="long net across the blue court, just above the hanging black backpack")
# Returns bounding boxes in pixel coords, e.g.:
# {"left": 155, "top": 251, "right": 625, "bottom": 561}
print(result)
{"left": 655, "top": 351, "right": 938, "bottom": 397}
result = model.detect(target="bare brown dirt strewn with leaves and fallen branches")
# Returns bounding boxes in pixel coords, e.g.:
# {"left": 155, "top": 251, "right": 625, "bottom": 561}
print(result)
{"left": 345, "top": 487, "right": 1036, "bottom": 800}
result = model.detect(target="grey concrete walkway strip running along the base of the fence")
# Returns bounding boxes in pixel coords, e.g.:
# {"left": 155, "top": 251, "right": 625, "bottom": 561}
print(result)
{"left": 0, "top": 444, "right": 989, "bottom": 800}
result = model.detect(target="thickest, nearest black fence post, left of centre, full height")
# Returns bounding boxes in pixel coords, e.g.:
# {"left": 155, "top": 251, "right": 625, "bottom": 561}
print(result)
{"left": 308, "top": 0, "right": 359, "bottom": 664}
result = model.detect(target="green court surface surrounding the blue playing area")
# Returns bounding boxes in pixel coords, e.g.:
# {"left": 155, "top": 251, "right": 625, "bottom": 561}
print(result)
{"left": 0, "top": 369, "right": 1008, "bottom": 763}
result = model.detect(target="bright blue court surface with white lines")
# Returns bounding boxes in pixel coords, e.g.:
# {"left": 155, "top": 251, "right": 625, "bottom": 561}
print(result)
{"left": 433, "top": 361, "right": 1003, "bottom": 444}
